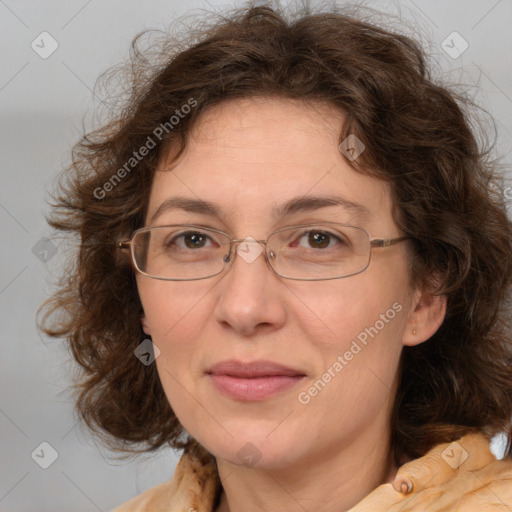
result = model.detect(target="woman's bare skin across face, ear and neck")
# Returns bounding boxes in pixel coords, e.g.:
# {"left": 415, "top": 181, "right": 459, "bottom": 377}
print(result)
{"left": 137, "top": 98, "right": 445, "bottom": 512}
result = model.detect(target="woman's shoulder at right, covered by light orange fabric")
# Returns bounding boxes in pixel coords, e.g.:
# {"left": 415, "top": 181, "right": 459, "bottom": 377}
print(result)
{"left": 350, "top": 434, "right": 512, "bottom": 512}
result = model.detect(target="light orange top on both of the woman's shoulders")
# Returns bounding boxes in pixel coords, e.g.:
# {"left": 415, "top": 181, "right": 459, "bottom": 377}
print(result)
{"left": 113, "top": 434, "right": 512, "bottom": 512}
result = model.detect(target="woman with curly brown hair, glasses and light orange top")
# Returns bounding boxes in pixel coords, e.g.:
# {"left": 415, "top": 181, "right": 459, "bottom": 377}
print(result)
{"left": 41, "top": 2, "right": 512, "bottom": 512}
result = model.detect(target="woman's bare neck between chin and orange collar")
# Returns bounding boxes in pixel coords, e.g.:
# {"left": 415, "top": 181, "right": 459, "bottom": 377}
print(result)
{"left": 216, "top": 432, "right": 397, "bottom": 512}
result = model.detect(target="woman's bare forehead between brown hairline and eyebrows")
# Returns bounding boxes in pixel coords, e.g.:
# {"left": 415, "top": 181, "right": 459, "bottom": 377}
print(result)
{"left": 148, "top": 98, "right": 391, "bottom": 230}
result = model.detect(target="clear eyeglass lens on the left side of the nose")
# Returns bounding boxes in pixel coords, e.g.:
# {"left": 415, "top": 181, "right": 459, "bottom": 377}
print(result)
{"left": 132, "top": 225, "right": 229, "bottom": 280}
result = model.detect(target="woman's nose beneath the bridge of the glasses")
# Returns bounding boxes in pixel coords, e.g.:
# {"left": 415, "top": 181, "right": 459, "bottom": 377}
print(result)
{"left": 215, "top": 237, "right": 286, "bottom": 336}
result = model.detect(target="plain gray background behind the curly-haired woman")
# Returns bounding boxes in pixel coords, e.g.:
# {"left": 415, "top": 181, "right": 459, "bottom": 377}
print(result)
{"left": 0, "top": 0, "right": 512, "bottom": 512}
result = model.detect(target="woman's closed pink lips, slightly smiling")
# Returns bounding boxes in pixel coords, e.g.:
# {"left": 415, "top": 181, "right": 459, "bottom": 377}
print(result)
{"left": 206, "top": 360, "right": 305, "bottom": 401}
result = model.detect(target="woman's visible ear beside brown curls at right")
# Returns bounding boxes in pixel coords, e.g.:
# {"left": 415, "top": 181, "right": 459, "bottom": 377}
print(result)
{"left": 402, "top": 290, "right": 446, "bottom": 346}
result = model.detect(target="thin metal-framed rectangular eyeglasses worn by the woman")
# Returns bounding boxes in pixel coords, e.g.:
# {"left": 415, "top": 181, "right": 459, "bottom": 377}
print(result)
{"left": 118, "top": 222, "right": 409, "bottom": 281}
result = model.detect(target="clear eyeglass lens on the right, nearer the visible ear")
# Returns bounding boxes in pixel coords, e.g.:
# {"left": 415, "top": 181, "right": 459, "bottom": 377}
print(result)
{"left": 268, "top": 223, "right": 371, "bottom": 280}
